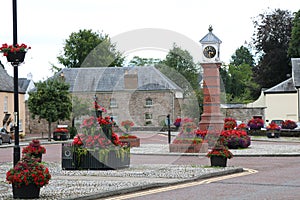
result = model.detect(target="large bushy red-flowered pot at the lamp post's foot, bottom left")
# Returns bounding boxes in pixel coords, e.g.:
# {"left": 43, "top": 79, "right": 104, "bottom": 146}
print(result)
{"left": 6, "top": 154, "right": 51, "bottom": 199}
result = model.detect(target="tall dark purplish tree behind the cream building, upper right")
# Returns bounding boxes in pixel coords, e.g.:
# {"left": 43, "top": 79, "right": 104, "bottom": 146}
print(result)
{"left": 253, "top": 9, "right": 292, "bottom": 88}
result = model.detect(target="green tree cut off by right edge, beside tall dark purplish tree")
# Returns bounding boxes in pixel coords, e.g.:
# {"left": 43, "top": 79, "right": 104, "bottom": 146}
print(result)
{"left": 288, "top": 10, "right": 300, "bottom": 58}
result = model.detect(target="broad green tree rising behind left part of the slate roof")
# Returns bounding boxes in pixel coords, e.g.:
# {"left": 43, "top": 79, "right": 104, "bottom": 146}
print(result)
{"left": 57, "top": 29, "right": 124, "bottom": 68}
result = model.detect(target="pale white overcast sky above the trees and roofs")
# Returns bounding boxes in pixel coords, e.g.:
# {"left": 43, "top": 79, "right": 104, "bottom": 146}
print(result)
{"left": 0, "top": 0, "right": 300, "bottom": 81}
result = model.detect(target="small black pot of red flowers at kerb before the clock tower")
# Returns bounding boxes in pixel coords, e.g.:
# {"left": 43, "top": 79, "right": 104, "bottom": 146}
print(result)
{"left": 206, "top": 142, "right": 233, "bottom": 167}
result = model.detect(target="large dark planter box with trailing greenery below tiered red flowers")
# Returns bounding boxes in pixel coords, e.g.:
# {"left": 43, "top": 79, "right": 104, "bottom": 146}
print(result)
{"left": 62, "top": 143, "right": 130, "bottom": 170}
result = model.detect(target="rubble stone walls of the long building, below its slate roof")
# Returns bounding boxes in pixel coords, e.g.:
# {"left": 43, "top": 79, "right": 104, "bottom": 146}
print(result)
{"left": 26, "top": 90, "right": 181, "bottom": 137}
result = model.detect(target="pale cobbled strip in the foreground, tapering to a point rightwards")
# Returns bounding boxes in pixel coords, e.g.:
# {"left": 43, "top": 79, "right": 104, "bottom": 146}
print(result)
{"left": 0, "top": 162, "right": 242, "bottom": 199}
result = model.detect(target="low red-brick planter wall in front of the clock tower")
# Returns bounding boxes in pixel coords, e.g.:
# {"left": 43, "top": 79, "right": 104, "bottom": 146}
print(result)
{"left": 169, "top": 143, "right": 208, "bottom": 153}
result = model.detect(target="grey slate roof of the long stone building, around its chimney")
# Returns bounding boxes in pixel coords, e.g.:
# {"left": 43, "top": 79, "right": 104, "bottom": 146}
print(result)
{"left": 57, "top": 66, "right": 182, "bottom": 92}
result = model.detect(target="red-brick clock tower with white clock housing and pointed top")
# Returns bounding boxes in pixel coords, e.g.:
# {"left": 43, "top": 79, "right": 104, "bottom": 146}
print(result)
{"left": 199, "top": 26, "right": 224, "bottom": 133}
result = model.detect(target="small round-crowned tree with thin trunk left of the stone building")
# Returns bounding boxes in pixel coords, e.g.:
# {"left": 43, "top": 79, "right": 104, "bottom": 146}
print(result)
{"left": 28, "top": 78, "right": 72, "bottom": 141}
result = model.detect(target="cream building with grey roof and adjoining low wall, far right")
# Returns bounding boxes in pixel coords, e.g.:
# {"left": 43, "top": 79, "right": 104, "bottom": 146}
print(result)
{"left": 221, "top": 58, "right": 300, "bottom": 123}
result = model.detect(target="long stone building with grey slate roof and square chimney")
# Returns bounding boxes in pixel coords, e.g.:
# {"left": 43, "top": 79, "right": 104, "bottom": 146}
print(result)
{"left": 30, "top": 66, "right": 184, "bottom": 133}
